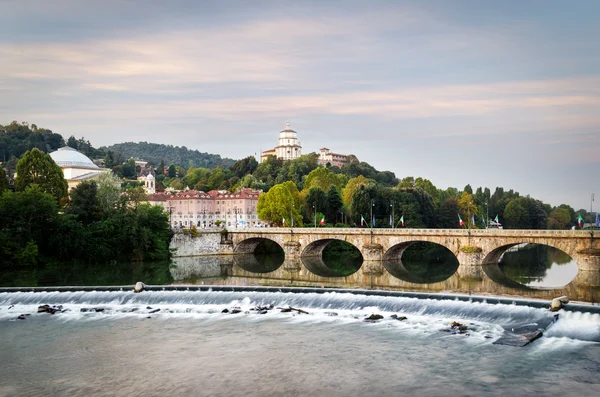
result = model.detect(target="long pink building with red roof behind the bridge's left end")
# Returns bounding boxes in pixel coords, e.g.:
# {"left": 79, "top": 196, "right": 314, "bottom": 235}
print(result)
{"left": 148, "top": 188, "right": 263, "bottom": 228}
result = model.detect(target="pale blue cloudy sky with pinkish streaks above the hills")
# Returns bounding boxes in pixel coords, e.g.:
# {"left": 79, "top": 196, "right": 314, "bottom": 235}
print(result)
{"left": 0, "top": 0, "right": 600, "bottom": 211}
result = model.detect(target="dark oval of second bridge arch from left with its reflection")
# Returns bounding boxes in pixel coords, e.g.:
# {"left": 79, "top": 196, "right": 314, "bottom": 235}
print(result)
{"left": 301, "top": 239, "right": 363, "bottom": 277}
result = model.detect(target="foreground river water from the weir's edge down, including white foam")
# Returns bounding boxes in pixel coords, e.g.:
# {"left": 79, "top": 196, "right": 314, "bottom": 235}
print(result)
{"left": 0, "top": 290, "right": 600, "bottom": 396}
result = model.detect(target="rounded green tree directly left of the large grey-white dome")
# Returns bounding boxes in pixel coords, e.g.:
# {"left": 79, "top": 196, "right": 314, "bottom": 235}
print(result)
{"left": 15, "top": 149, "right": 68, "bottom": 201}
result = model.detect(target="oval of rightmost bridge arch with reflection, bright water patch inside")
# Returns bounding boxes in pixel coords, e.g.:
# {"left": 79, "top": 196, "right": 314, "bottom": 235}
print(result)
{"left": 483, "top": 243, "right": 578, "bottom": 289}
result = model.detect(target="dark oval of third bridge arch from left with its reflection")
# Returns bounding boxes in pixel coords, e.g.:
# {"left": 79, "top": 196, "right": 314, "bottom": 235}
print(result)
{"left": 383, "top": 241, "right": 459, "bottom": 284}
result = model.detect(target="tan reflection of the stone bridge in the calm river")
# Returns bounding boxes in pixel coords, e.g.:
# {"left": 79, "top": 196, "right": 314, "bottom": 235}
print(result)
{"left": 166, "top": 255, "right": 600, "bottom": 302}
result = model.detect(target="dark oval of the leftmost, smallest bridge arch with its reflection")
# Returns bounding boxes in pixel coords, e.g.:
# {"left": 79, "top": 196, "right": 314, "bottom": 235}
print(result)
{"left": 233, "top": 238, "right": 285, "bottom": 273}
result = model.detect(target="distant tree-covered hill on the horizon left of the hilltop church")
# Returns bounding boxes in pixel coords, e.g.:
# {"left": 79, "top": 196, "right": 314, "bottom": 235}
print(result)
{"left": 100, "top": 142, "right": 235, "bottom": 169}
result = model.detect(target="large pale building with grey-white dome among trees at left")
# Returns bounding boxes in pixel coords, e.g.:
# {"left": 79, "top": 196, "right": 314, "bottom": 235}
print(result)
{"left": 50, "top": 146, "right": 107, "bottom": 190}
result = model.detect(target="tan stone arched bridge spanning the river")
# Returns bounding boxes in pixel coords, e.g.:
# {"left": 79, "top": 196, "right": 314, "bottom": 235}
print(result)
{"left": 226, "top": 228, "right": 600, "bottom": 273}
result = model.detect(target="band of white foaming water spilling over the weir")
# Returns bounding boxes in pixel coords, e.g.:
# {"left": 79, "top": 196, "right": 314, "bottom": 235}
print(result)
{"left": 0, "top": 291, "right": 600, "bottom": 343}
